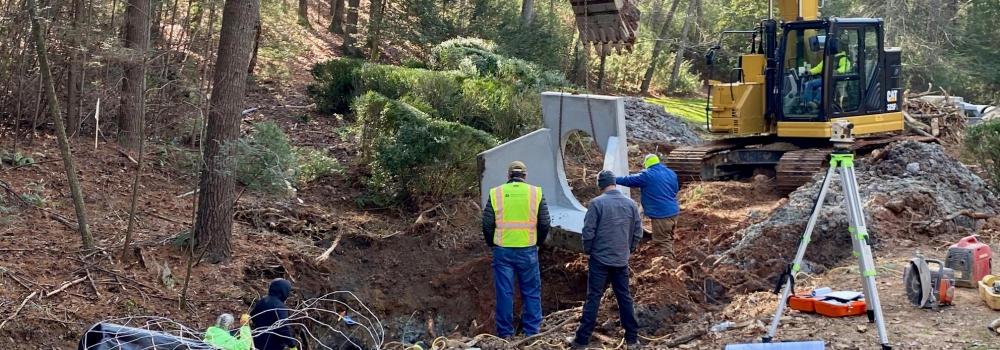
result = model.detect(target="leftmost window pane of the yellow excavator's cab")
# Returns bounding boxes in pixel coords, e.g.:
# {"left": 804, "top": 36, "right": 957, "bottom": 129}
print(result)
{"left": 780, "top": 27, "right": 827, "bottom": 120}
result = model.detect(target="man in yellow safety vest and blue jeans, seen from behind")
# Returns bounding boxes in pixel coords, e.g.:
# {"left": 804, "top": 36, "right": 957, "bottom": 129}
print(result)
{"left": 483, "top": 161, "right": 549, "bottom": 338}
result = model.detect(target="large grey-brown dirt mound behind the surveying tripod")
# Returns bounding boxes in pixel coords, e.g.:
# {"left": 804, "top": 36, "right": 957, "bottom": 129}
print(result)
{"left": 719, "top": 141, "right": 1000, "bottom": 290}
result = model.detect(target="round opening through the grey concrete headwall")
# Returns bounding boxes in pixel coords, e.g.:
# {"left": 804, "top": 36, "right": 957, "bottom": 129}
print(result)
{"left": 562, "top": 130, "right": 604, "bottom": 207}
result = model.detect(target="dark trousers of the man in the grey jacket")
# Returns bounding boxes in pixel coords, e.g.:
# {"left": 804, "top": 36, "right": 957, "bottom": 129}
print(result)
{"left": 573, "top": 258, "right": 639, "bottom": 345}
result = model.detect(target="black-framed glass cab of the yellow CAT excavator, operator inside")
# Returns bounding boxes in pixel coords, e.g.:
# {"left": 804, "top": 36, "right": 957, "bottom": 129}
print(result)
{"left": 769, "top": 18, "right": 901, "bottom": 137}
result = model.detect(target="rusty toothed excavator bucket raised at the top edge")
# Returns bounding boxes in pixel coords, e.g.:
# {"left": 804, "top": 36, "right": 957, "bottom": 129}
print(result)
{"left": 570, "top": 0, "right": 639, "bottom": 52}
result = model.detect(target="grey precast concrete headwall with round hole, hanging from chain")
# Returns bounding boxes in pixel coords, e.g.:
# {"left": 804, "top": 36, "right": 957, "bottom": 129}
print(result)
{"left": 478, "top": 92, "right": 629, "bottom": 251}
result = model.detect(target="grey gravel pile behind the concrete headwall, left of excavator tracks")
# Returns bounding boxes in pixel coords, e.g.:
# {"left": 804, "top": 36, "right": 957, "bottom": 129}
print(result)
{"left": 625, "top": 97, "right": 702, "bottom": 145}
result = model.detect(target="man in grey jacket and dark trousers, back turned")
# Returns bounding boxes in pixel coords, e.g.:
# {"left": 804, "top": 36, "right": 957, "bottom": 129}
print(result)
{"left": 572, "top": 170, "right": 642, "bottom": 349}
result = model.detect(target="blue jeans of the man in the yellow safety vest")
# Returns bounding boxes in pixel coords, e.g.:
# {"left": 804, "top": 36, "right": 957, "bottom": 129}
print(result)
{"left": 493, "top": 247, "right": 542, "bottom": 338}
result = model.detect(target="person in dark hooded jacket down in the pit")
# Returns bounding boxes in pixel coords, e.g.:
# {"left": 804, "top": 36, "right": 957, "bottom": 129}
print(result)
{"left": 250, "top": 278, "right": 298, "bottom": 350}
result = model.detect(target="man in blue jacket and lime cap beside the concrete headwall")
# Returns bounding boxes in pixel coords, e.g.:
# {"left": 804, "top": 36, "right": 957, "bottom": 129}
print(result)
{"left": 615, "top": 154, "right": 681, "bottom": 256}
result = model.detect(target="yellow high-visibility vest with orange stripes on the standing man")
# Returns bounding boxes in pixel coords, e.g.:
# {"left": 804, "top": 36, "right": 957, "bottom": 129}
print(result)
{"left": 490, "top": 182, "right": 542, "bottom": 248}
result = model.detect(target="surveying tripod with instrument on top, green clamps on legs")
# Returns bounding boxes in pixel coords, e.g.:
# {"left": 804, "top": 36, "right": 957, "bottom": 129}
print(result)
{"left": 761, "top": 122, "right": 892, "bottom": 350}
